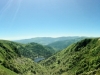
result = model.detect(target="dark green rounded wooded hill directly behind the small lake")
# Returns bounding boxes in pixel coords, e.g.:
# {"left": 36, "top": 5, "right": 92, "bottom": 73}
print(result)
{"left": 19, "top": 43, "right": 55, "bottom": 60}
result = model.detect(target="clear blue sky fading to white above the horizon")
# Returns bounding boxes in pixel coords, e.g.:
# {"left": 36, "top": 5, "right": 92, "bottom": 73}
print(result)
{"left": 0, "top": 0, "right": 100, "bottom": 40}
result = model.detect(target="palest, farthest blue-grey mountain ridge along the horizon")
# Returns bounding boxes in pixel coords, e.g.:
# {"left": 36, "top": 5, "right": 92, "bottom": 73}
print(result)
{"left": 14, "top": 36, "right": 86, "bottom": 45}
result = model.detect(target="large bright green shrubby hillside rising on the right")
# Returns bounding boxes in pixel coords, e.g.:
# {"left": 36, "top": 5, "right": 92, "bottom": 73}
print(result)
{"left": 41, "top": 38, "right": 100, "bottom": 75}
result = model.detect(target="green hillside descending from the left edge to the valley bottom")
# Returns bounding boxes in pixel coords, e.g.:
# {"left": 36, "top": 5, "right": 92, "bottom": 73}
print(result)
{"left": 0, "top": 40, "right": 47, "bottom": 75}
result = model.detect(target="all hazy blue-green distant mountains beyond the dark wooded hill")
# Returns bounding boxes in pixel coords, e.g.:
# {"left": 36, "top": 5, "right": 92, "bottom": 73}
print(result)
{"left": 15, "top": 36, "right": 87, "bottom": 52}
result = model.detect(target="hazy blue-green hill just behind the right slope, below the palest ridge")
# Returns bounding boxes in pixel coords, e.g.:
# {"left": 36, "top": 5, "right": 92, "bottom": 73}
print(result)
{"left": 48, "top": 37, "right": 85, "bottom": 52}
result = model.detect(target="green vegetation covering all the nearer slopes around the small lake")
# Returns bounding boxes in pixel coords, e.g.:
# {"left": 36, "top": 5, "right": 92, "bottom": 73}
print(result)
{"left": 0, "top": 38, "right": 100, "bottom": 75}
